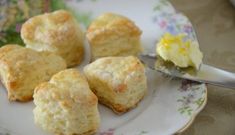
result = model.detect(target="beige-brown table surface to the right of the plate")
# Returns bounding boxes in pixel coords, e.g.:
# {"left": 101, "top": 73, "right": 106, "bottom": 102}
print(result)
{"left": 170, "top": 0, "right": 235, "bottom": 135}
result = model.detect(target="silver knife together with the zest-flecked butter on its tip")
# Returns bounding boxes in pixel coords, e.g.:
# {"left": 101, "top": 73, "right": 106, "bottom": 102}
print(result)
{"left": 139, "top": 33, "right": 235, "bottom": 89}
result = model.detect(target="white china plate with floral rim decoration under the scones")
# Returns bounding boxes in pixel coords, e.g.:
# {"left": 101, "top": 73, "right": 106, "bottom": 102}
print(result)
{"left": 0, "top": 0, "right": 207, "bottom": 135}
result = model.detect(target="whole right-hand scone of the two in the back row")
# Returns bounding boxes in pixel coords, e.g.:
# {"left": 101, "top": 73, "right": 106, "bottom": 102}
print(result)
{"left": 86, "top": 13, "right": 142, "bottom": 61}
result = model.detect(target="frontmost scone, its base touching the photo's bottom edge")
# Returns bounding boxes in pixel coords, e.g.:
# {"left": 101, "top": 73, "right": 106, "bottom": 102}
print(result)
{"left": 33, "top": 69, "right": 100, "bottom": 135}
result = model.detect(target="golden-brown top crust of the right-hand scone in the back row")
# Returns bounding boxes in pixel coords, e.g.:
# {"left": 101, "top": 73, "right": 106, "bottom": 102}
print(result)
{"left": 86, "top": 13, "right": 142, "bottom": 45}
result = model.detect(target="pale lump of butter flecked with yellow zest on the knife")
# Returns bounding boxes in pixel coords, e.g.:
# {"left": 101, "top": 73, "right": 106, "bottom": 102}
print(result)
{"left": 156, "top": 33, "right": 203, "bottom": 70}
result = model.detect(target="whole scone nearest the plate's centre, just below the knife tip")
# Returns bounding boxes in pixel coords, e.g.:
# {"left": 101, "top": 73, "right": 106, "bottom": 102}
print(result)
{"left": 84, "top": 56, "right": 147, "bottom": 114}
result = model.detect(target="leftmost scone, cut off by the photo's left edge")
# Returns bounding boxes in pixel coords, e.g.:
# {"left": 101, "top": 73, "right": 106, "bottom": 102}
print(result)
{"left": 0, "top": 45, "right": 66, "bottom": 101}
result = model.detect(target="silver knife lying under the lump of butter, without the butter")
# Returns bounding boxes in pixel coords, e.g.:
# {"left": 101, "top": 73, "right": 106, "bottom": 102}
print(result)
{"left": 139, "top": 54, "right": 235, "bottom": 89}
